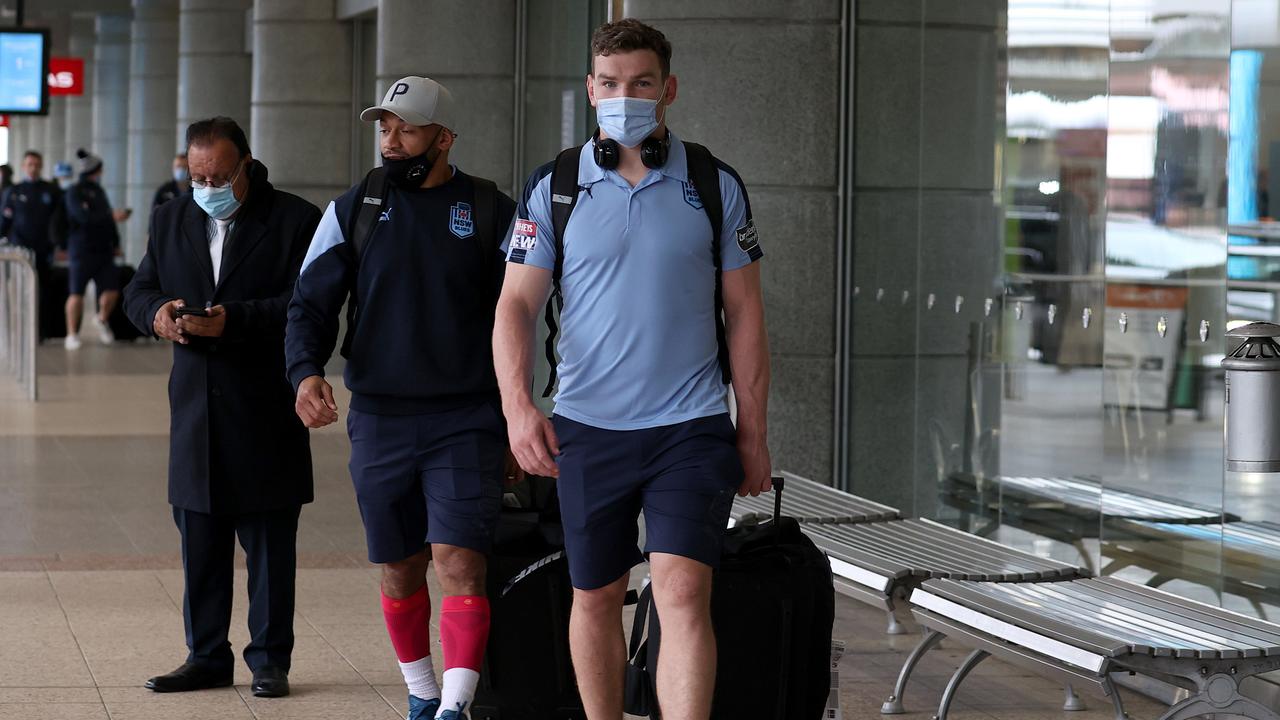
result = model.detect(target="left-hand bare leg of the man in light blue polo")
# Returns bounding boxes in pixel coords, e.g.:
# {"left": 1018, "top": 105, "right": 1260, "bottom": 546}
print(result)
{"left": 568, "top": 573, "right": 630, "bottom": 720}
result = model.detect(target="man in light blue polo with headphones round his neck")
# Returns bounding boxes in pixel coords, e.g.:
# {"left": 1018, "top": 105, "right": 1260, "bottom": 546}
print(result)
{"left": 494, "top": 19, "right": 771, "bottom": 720}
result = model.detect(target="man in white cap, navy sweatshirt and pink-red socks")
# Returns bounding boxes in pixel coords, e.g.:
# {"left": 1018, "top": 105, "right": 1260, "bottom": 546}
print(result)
{"left": 285, "top": 77, "right": 516, "bottom": 720}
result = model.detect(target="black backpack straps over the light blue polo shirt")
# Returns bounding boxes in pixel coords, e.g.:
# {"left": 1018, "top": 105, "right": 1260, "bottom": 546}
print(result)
{"left": 543, "top": 142, "right": 732, "bottom": 397}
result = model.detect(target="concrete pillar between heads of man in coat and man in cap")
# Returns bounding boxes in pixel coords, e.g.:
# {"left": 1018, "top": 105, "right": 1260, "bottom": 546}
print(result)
{"left": 250, "top": 0, "right": 353, "bottom": 208}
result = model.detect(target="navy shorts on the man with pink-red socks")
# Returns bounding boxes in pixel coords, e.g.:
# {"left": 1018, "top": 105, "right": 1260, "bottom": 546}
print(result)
{"left": 347, "top": 402, "right": 507, "bottom": 562}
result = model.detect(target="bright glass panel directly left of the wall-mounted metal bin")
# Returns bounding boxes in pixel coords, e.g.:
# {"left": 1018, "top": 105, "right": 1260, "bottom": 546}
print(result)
{"left": 1101, "top": 0, "right": 1230, "bottom": 602}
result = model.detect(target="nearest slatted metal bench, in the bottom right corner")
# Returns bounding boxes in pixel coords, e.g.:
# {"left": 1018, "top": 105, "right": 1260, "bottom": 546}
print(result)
{"left": 910, "top": 578, "right": 1280, "bottom": 720}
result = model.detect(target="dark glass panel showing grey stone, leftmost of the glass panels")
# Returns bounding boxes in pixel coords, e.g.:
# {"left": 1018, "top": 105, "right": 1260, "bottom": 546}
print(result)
{"left": 911, "top": 0, "right": 1009, "bottom": 534}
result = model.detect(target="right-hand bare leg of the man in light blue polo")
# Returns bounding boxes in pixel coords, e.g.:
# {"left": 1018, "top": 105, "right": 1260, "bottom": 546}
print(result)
{"left": 649, "top": 552, "right": 716, "bottom": 720}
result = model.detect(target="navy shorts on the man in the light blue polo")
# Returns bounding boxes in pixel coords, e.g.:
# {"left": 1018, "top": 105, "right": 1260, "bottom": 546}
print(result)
{"left": 552, "top": 414, "right": 742, "bottom": 589}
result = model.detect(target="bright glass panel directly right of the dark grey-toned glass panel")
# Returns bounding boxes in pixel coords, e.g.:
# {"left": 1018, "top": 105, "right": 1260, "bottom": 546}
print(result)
{"left": 951, "top": 0, "right": 1108, "bottom": 566}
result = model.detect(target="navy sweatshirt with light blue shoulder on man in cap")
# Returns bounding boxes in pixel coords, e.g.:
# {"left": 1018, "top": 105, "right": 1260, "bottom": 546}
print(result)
{"left": 284, "top": 170, "right": 516, "bottom": 415}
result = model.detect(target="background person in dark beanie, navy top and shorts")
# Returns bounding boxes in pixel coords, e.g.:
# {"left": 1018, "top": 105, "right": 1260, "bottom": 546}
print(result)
{"left": 64, "top": 149, "right": 133, "bottom": 350}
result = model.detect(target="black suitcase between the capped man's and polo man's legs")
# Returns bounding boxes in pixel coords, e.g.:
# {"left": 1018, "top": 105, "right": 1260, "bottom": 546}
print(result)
{"left": 470, "top": 478, "right": 586, "bottom": 720}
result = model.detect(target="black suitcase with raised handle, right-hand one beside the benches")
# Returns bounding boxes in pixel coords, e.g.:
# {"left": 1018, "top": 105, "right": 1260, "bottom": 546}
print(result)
{"left": 626, "top": 478, "right": 836, "bottom": 720}
